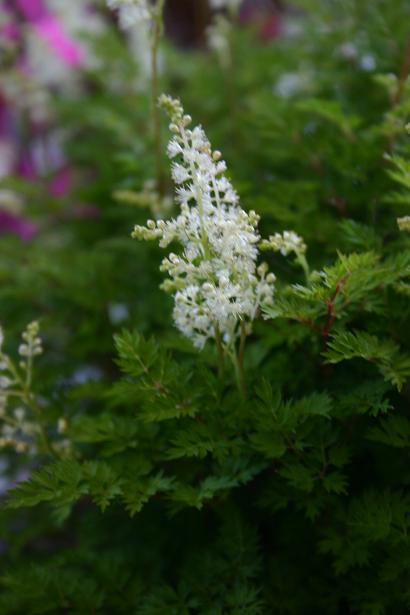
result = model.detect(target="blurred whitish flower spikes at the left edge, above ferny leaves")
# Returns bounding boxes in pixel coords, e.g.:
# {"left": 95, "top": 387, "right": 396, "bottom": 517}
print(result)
{"left": 0, "top": 322, "right": 70, "bottom": 453}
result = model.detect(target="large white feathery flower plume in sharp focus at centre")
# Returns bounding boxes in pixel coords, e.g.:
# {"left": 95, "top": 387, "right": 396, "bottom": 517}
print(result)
{"left": 133, "top": 96, "right": 275, "bottom": 350}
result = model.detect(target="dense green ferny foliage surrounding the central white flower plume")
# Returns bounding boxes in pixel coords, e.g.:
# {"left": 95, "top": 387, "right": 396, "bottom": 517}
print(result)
{"left": 0, "top": 0, "right": 410, "bottom": 615}
